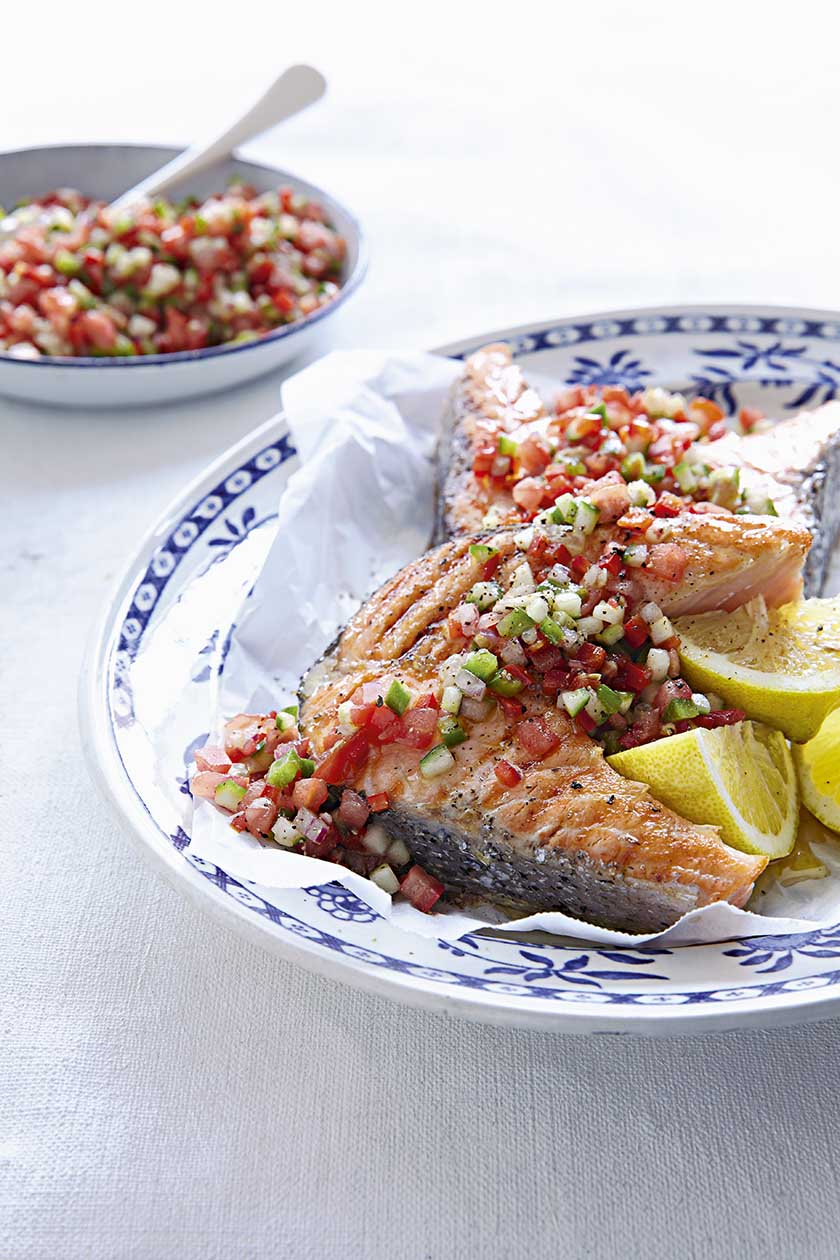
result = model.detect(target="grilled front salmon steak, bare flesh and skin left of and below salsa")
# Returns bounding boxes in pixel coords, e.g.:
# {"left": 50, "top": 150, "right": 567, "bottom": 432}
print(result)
{"left": 300, "top": 529, "right": 766, "bottom": 932}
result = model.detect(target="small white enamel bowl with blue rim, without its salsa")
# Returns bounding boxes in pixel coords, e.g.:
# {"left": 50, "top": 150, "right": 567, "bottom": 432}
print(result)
{"left": 0, "top": 144, "right": 366, "bottom": 407}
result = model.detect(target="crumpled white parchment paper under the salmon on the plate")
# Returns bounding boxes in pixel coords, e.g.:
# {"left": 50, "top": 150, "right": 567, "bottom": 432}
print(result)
{"left": 190, "top": 350, "right": 840, "bottom": 945}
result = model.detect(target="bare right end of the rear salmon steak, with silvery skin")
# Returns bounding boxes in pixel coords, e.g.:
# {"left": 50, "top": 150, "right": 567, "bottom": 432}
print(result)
{"left": 704, "top": 402, "right": 840, "bottom": 595}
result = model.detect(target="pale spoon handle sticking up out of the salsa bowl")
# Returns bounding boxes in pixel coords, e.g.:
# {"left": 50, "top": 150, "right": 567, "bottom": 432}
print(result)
{"left": 111, "top": 66, "right": 326, "bottom": 210}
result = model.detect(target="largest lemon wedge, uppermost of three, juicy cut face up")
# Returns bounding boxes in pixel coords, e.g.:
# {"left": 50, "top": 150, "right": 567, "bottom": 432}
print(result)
{"left": 675, "top": 597, "right": 840, "bottom": 743}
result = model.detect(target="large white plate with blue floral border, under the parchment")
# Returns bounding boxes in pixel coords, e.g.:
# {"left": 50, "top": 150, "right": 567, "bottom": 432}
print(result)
{"left": 82, "top": 306, "right": 840, "bottom": 1036}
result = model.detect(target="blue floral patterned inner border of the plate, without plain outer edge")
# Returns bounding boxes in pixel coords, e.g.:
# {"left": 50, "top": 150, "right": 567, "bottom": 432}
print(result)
{"left": 88, "top": 309, "right": 840, "bottom": 1028}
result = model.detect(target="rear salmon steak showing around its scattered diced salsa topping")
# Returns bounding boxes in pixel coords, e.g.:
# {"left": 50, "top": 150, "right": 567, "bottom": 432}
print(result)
{"left": 437, "top": 344, "right": 840, "bottom": 607}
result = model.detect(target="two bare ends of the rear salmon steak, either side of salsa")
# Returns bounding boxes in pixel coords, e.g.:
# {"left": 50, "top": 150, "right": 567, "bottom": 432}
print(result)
{"left": 436, "top": 344, "right": 840, "bottom": 594}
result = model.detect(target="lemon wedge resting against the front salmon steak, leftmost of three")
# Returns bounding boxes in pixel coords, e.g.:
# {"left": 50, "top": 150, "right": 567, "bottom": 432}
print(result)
{"left": 607, "top": 722, "right": 798, "bottom": 859}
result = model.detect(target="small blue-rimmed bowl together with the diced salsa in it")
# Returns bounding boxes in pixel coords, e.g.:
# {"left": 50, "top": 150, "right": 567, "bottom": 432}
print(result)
{"left": 0, "top": 145, "right": 364, "bottom": 406}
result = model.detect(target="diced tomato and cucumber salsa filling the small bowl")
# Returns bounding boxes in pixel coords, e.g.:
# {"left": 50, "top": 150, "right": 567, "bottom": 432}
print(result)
{"left": 0, "top": 181, "right": 345, "bottom": 359}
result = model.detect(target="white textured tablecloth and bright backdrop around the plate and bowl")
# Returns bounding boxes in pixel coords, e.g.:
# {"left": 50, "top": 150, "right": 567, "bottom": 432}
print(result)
{"left": 0, "top": 0, "right": 840, "bottom": 1260}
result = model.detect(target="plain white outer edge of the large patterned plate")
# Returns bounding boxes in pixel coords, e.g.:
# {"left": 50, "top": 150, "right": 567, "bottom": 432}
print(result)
{"left": 78, "top": 301, "right": 840, "bottom": 1036}
